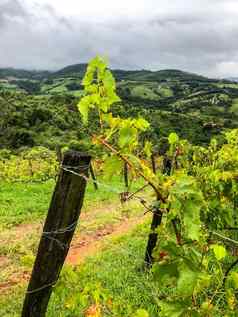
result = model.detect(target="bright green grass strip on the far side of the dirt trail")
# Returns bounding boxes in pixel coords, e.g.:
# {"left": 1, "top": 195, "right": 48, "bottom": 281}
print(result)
{"left": 0, "top": 177, "right": 138, "bottom": 228}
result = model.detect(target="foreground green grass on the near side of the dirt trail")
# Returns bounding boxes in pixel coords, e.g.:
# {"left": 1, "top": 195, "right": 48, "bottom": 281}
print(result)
{"left": 0, "top": 220, "right": 158, "bottom": 317}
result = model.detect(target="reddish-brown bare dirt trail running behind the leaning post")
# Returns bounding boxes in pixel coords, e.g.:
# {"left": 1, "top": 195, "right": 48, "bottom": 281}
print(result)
{"left": 0, "top": 201, "right": 146, "bottom": 294}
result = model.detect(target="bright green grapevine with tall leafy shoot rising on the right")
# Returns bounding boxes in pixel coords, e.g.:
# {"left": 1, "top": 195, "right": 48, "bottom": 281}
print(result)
{"left": 78, "top": 57, "right": 238, "bottom": 317}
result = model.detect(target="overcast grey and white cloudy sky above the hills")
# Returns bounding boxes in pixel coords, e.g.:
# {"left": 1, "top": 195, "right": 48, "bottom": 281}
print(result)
{"left": 0, "top": 0, "right": 238, "bottom": 77}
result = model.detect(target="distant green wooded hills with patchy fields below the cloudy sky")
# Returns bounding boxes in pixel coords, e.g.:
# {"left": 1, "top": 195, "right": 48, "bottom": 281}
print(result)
{"left": 0, "top": 64, "right": 238, "bottom": 148}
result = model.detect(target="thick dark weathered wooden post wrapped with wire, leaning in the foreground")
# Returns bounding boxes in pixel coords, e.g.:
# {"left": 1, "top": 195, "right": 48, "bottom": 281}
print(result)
{"left": 22, "top": 151, "right": 91, "bottom": 317}
